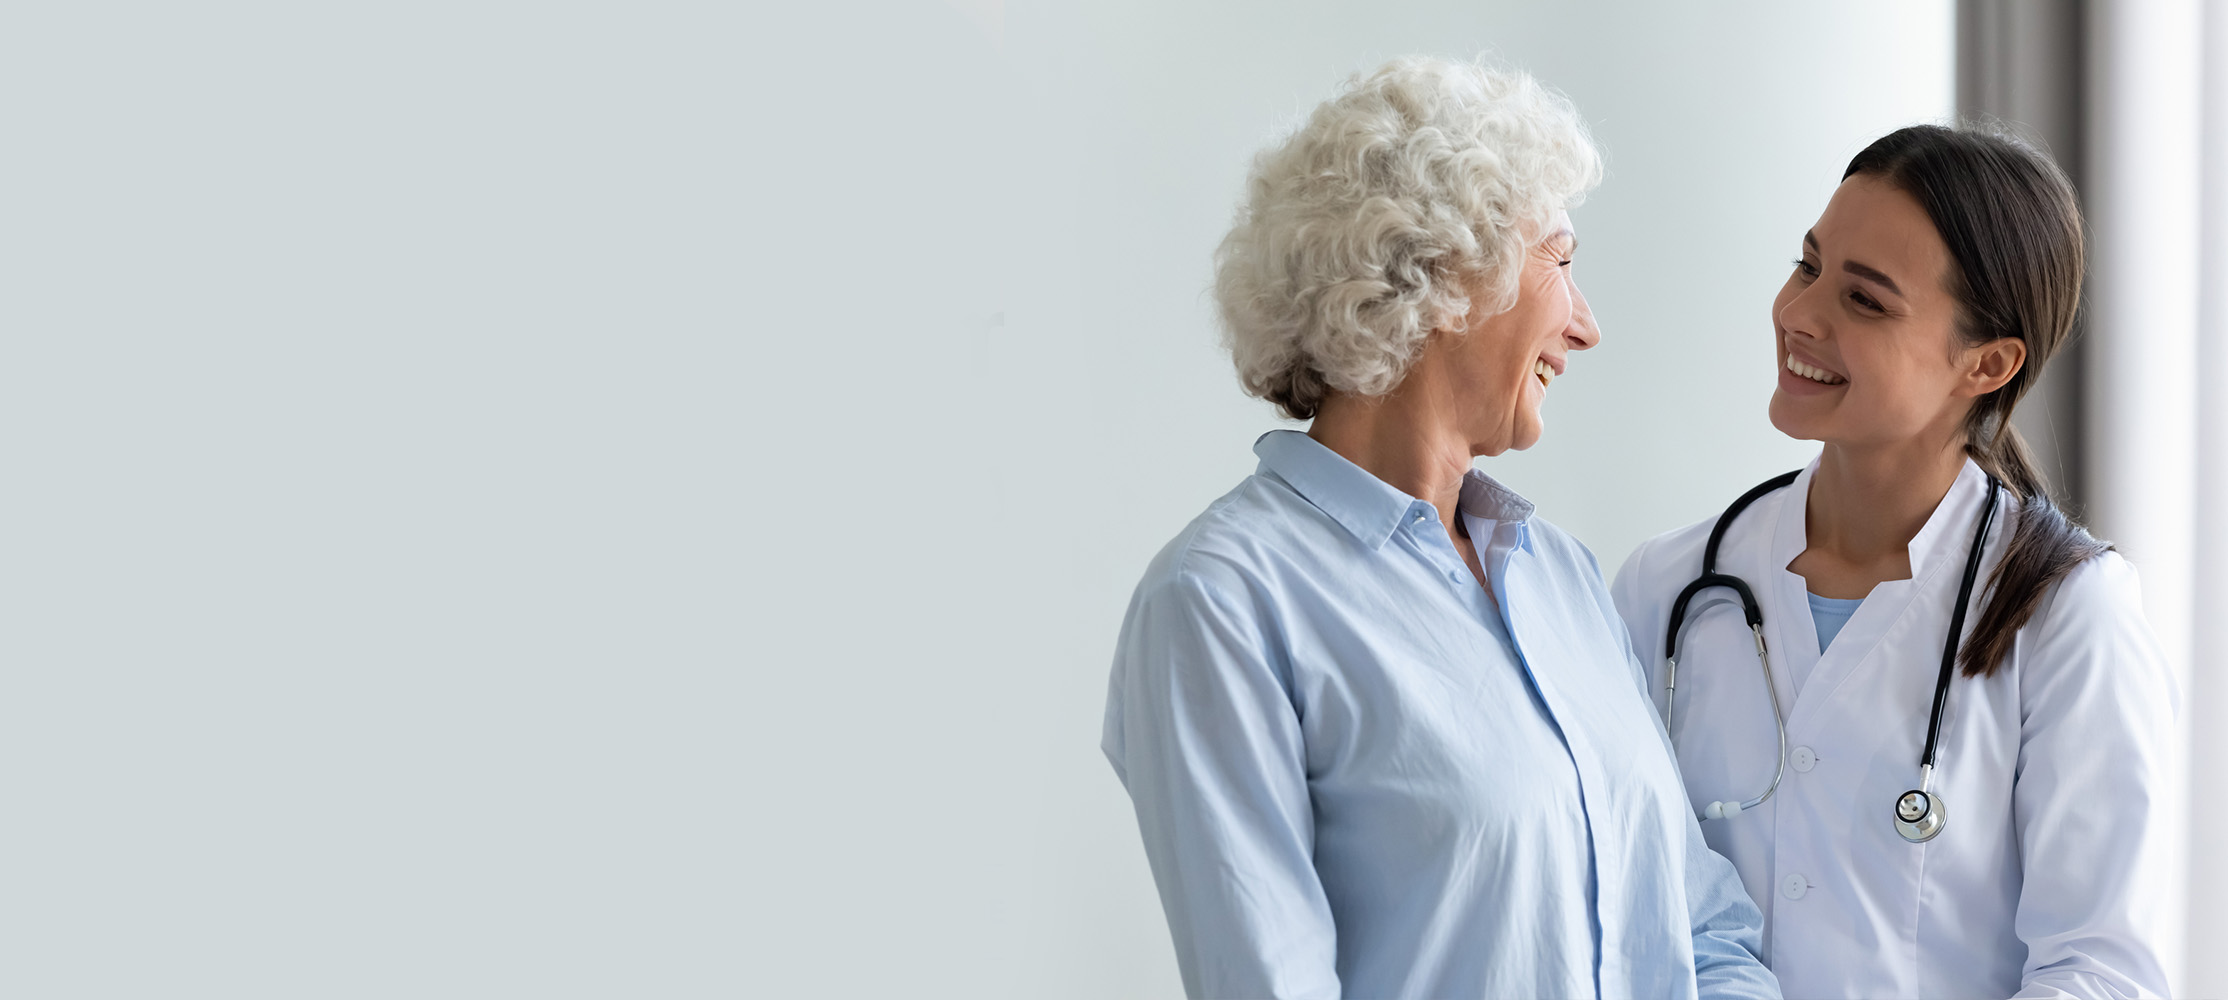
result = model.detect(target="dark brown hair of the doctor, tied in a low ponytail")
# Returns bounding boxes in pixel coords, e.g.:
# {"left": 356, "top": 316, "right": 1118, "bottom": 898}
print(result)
{"left": 1843, "top": 125, "right": 2112, "bottom": 677}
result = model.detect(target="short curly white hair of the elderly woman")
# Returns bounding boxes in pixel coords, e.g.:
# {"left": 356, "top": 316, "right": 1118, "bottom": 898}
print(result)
{"left": 1214, "top": 56, "right": 1602, "bottom": 421}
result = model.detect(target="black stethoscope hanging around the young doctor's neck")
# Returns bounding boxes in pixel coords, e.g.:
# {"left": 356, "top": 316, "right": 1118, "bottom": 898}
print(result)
{"left": 1664, "top": 472, "right": 2001, "bottom": 844}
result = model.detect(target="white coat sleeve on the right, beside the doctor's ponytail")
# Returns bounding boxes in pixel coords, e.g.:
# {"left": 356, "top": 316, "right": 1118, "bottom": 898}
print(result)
{"left": 2012, "top": 552, "right": 2177, "bottom": 998}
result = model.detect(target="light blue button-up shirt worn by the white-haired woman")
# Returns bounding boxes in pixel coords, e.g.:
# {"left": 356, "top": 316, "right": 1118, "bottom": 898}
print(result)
{"left": 1103, "top": 432, "right": 1778, "bottom": 998}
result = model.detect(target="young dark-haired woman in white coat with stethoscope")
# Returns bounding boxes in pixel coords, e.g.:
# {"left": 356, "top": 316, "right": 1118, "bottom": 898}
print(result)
{"left": 1613, "top": 127, "right": 2177, "bottom": 998}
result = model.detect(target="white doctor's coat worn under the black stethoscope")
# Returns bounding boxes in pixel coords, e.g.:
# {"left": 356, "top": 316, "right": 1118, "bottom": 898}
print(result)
{"left": 1611, "top": 461, "right": 2177, "bottom": 998}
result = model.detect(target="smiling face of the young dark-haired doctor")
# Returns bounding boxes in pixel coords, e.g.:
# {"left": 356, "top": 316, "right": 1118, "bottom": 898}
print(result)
{"left": 1771, "top": 174, "right": 1972, "bottom": 445}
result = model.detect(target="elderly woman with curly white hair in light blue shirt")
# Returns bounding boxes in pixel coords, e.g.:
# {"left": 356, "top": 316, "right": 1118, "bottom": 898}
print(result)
{"left": 1105, "top": 58, "right": 1778, "bottom": 998}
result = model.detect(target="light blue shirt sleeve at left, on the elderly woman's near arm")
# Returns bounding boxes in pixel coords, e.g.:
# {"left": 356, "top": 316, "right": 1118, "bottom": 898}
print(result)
{"left": 1103, "top": 575, "right": 1339, "bottom": 998}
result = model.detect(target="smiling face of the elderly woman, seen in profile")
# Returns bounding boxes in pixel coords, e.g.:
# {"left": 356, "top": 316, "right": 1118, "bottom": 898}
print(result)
{"left": 1448, "top": 212, "right": 1602, "bottom": 454}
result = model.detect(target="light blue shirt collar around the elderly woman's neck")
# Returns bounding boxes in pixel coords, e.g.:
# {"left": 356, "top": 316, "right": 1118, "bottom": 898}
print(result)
{"left": 1254, "top": 430, "right": 1533, "bottom": 550}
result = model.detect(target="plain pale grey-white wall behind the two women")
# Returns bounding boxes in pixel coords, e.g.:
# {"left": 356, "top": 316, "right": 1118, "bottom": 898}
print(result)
{"left": 0, "top": 0, "right": 1952, "bottom": 998}
